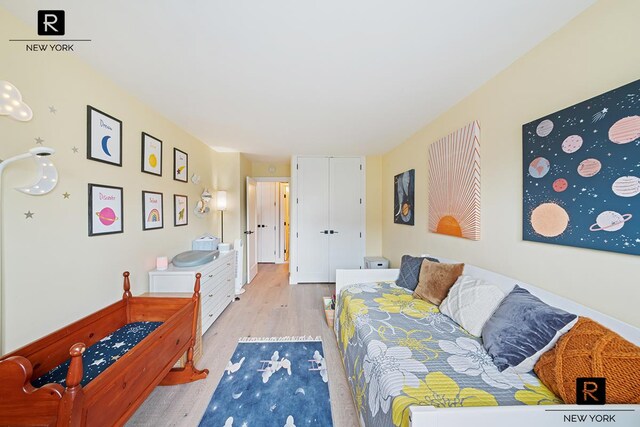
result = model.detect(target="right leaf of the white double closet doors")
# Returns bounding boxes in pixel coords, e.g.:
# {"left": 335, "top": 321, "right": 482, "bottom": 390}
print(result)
{"left": 329, "top": 157, "right": 364, "bottom": 282}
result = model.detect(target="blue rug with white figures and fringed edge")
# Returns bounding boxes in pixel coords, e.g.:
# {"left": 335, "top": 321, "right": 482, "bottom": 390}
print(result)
{"left": 200, "top": 337, "right": 333, "bottom": 427}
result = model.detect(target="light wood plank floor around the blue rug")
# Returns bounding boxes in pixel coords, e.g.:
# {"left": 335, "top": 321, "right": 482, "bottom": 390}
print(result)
{"left": 127, "top": 264, "right": 358, "bottom": 427}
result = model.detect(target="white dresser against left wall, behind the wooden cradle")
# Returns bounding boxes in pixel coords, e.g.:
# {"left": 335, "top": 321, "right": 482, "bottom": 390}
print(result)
{"left": 149, "top": 251, "right": 236, "bottom": 334}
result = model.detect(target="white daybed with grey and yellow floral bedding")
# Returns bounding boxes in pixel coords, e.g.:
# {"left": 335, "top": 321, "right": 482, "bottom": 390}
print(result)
{"left": 334, "top": 258, "right": 640, "bottom": 427}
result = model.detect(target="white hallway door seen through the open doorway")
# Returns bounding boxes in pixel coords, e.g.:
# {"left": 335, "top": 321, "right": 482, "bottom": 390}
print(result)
{"left": 258, "top": 182, "right": 278, "bottom": 262}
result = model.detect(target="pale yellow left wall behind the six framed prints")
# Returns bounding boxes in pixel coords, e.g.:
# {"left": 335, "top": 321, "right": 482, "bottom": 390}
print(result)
{"left": 0, "top": 8, "right": 222, "bottom": 350}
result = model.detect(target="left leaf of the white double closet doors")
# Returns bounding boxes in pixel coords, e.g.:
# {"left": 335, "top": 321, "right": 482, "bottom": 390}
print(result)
{"left": 296, "top": 157, "right": 331, "bottom": 283}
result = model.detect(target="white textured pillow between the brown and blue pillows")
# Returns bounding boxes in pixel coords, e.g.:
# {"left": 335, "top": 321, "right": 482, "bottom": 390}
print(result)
{"left": 440, "top": 275, "right": 507, "bottom": 337}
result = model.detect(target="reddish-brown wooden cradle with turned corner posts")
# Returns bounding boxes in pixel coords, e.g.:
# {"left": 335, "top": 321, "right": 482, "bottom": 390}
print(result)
{"left": 0, "top": 272, "right": 209, "bottom": 426}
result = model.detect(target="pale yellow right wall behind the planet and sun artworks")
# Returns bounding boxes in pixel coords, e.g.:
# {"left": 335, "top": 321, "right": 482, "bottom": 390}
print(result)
{"left": 382, "top": 0, "right": 640, "bottom": 326}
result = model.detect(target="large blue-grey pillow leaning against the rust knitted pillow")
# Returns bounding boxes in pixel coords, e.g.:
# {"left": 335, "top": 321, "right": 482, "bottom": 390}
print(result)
{"left": 482, "top": 285, "right": 578, "bottom": 373}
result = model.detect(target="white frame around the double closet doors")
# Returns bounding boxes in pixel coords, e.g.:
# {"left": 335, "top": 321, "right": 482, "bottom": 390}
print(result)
{"left": 289, "top": 154, "right": 367, "bottom": 285}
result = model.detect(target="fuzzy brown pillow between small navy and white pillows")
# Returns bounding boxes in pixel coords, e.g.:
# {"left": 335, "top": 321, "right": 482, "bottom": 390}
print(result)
{"left": 413, "top": 259, "right": 464, "bottom": 305}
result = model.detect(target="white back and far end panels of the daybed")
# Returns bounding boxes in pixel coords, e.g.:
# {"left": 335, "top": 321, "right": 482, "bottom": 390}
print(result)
{"left": 336, "top": 254, "right": 640, "bottom": 345}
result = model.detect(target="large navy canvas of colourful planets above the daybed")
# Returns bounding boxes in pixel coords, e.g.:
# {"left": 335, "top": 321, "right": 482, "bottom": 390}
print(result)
{"left": 522, "top": 80, "right": 640, "bottom": 255}
